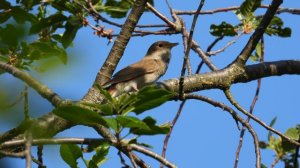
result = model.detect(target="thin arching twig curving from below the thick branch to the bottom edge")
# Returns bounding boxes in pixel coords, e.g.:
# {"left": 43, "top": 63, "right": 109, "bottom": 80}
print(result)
{"left": 185, "top": 94, "right": 261, "bottom": 168}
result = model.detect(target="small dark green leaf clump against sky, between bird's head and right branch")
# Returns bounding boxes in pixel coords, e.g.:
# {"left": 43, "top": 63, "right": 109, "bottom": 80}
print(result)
{"left": 210, "top": 22, "right": 237, "bottom": 36}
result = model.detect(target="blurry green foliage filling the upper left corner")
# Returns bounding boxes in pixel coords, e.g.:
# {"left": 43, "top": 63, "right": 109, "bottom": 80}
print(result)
{"left": 0, "top": 0, "right": 148, "bottom": 70}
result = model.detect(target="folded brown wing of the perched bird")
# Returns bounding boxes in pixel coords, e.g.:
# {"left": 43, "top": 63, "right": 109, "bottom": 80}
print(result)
{"left": 107, "top": 59, "right": 159, "bottom": 85}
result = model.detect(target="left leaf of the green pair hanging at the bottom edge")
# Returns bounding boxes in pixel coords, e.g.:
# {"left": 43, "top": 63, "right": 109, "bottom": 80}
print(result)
{"left": 60, "top": 144, "right": 82, "bottom": 168}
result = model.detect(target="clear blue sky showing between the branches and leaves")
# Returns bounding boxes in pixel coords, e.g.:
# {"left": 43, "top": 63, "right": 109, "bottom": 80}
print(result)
{"left": 0, "top": 0, "right": 300, "bottom": 168}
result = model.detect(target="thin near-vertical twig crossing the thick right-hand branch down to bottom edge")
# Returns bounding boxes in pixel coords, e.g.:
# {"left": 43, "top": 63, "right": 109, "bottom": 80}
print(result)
{"left": 234, "top": 37, "right": 264, "bottom": 168}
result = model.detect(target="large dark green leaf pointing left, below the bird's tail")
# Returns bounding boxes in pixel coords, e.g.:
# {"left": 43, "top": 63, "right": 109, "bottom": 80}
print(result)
{"left": 54, "top": 105, "right": 107, "bottom": 127}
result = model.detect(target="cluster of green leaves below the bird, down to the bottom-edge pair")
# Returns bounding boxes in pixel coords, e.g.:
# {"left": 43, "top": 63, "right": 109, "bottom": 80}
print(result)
{"left": 54, "top": 86, "right": 174, "bottom": 168}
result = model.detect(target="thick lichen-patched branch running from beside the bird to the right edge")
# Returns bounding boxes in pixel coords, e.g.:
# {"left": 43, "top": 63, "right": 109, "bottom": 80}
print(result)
{"left": 160, "top": 60, "right": 300, "bottom": 93}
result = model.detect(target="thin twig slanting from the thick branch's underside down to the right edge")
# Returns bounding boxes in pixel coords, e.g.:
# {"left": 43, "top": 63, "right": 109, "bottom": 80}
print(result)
{"left": 224, "top": 89, "right": 300, "bottom": 146}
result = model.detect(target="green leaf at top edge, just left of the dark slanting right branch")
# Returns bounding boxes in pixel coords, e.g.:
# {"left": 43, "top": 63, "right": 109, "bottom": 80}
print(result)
{"left": 240, "top": 0, "right": 262, "bottom": 18}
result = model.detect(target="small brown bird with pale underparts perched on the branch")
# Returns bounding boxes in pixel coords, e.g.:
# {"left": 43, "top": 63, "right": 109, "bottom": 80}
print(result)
{"left": 103, "top": 41, "right": 178, "bottom": 97}
